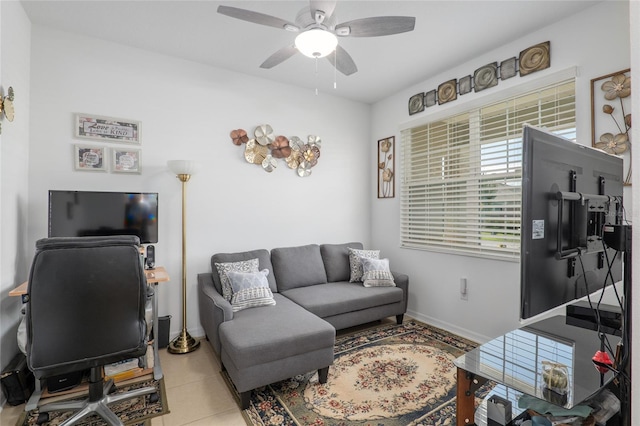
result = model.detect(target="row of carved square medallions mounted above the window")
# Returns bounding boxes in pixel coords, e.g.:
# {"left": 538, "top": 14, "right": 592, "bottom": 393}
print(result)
{"left": 409, "top": 41, "right": 551, "bottom": 115}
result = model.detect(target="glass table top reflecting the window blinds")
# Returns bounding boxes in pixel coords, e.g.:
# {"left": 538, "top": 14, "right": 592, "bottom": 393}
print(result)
{"left": 454, "top": 316, "right": 620, "bottom": 408}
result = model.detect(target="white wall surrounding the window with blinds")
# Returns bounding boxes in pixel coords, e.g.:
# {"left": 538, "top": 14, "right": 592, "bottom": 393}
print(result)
{"left": 370, "top": 2, "right": 631, "bottom": 340}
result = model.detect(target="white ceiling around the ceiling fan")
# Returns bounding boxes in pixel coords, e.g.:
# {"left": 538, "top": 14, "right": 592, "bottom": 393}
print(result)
{"left": 22, "top": 0, "right": 598, "bottom": 103}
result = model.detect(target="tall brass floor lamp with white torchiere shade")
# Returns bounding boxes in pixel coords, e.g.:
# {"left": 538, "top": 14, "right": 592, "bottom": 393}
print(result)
{"left": 167, "top": 160, "right": 200, "bottom": 354}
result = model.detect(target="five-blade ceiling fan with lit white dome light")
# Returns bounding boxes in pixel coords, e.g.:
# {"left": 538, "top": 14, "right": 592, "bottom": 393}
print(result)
{"left": 218, "top": 0, "right": 416, "bottom": 75}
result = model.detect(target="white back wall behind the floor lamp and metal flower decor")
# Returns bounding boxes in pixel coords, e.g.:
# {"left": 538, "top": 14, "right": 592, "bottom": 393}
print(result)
{"left": 28, "top": 26, "right": 370, "bottom": 336}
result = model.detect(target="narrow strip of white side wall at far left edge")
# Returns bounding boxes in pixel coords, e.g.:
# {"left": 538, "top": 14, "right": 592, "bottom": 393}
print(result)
{"left": 0, "top": 2, "right": 31, "bottom": 406}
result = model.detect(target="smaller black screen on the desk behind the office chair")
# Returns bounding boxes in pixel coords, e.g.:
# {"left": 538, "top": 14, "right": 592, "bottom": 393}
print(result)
{"left": 49, "top": 190, "right": 158, "bottom": 244}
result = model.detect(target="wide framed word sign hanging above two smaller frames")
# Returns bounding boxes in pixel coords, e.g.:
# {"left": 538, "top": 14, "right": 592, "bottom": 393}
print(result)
{"left": 75, "top": 114, "right": 141, "bottom": 145}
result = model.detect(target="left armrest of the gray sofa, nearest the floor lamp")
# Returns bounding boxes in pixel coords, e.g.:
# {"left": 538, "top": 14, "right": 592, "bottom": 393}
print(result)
{"left": 198, "top": 272, "right": 233, "bottom": 355}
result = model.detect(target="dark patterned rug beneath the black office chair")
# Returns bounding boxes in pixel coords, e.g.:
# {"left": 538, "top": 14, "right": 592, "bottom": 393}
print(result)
{"left": 16, "top": 379, "right": 169, "bottom": 426}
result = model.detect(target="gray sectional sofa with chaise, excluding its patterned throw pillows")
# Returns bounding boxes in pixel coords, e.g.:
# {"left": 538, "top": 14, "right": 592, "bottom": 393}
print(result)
{"left": 198, "top": 242, "right": 409, "bottom": 409}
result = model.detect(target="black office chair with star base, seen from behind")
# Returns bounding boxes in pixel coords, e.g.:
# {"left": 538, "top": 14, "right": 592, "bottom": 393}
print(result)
{"left": 26, "top": 236, "right": 156, "bottom": 425}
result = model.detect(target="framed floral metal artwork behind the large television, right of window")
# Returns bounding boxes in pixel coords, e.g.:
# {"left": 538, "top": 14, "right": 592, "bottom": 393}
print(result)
{"left": 591, "top": 69, "right": 631, "bottom": 185}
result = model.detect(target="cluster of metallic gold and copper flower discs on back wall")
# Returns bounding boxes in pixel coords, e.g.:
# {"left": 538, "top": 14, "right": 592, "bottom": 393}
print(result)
{"left": 229, "top": 124, "right": 322, "bottom": 177}
